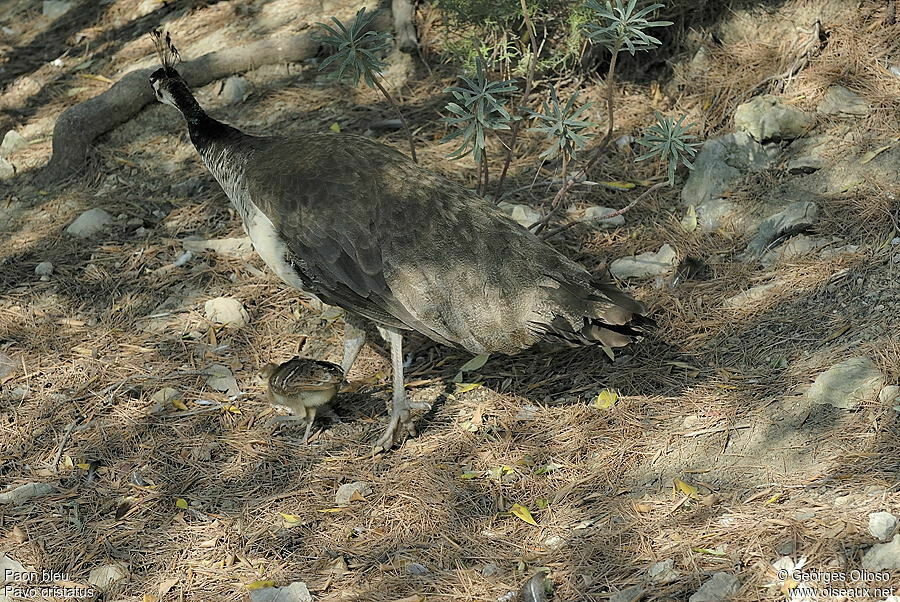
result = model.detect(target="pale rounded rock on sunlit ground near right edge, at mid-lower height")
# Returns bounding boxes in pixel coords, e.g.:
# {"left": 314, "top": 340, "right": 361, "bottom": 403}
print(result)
{"left": 806, "top": 356, "right": 884, "bottom": 409}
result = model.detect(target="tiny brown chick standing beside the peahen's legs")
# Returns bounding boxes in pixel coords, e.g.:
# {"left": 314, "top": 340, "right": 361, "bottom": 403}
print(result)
{"left": 259, "top": 357, "right": 344, "bottom": 444}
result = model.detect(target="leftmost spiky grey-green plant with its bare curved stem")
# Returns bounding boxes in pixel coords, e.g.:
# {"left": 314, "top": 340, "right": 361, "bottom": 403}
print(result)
{"left": 315, "top": 7, "right": 418, "bottom": 161}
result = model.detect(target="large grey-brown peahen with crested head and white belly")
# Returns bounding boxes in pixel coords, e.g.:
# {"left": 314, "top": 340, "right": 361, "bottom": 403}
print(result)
{"left": 150, "top": 32, "right": 652, "bottom": 451}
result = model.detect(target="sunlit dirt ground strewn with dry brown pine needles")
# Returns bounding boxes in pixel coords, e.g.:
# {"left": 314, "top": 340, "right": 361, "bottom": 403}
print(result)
{"left": 0, "top": 0, "right": 900, "bottom": 602}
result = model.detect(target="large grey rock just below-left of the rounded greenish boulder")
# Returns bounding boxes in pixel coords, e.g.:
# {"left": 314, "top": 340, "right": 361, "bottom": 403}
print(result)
{"left": 681, "top": 132, "right": 769, "bottom": 207}
